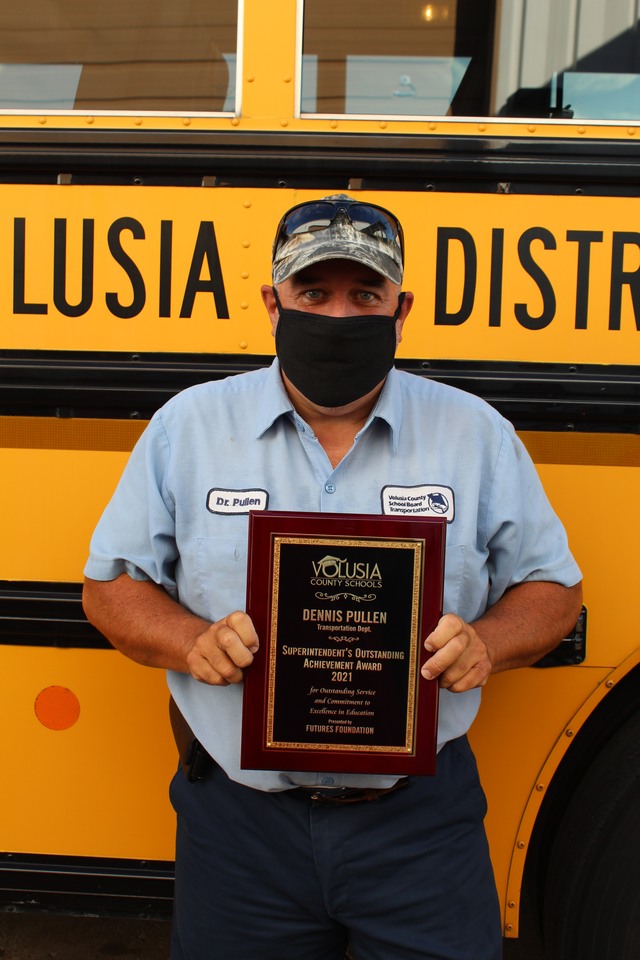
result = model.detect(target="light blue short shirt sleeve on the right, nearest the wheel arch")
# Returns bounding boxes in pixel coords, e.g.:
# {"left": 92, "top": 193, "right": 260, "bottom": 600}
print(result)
{"left": 485, "top": 421, "right": 581, "bottom": 606}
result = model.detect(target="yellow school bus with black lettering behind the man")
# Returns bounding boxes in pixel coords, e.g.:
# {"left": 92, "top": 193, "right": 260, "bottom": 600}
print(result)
{"left": 0, "top": 0, "right": 640, "bottom": 960}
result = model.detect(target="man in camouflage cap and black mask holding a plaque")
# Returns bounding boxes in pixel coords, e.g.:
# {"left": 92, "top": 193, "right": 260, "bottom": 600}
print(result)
{"left": 85, "top": 195, "right": 581, "bottom": 960}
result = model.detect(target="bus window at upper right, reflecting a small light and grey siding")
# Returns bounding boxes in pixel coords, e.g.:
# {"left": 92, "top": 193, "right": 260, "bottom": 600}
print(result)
{"left": 300, "top": 0, "right": 640, "bottom": 121}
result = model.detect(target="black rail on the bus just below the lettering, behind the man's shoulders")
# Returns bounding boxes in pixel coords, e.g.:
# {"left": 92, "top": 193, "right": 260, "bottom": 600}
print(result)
{"left": 0, "top": 350, "right": 640, "bottom": 434}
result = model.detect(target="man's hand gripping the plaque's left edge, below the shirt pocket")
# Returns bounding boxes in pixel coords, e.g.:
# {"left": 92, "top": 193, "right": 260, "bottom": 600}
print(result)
{"left": 187, "top": 610, "right": 259, "bottom": 687}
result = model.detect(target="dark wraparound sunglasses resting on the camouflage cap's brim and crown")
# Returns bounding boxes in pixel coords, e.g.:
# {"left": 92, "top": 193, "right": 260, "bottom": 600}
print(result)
{"left": 273, "top": 199, "right": 404, "bottom": 260}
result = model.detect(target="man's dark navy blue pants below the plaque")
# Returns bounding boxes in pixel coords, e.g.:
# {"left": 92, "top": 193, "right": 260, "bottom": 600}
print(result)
{"left": 171, "top": 737, "right": 502, "bottom": 960}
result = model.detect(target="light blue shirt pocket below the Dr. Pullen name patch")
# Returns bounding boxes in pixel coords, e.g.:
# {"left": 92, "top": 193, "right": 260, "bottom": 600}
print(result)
{"left": 194, "top": 535, "right": 247, "bottom": 623}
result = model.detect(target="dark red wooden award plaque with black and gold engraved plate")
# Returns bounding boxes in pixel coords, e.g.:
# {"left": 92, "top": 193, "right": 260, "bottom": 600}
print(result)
{"left": 241, "top": 511, "right": 446, "bottom": 775}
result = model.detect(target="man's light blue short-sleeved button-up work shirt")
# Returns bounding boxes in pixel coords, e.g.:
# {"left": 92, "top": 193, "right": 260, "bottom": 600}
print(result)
{"left": 85, "top": 360, "right": 580, "bottom": 790}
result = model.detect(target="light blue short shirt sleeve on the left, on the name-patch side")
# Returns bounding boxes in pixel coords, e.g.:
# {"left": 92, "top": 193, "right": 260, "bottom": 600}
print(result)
{"left": 84, "top": 413, "right": 178, "bottom": 594}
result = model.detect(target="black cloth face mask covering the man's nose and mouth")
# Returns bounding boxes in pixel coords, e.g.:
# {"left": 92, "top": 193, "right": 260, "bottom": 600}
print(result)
{"left": 274, "top": 287, "right": 404, "bottom": 407}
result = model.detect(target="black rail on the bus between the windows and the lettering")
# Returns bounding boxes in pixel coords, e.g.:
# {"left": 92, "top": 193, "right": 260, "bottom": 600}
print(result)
{"left": 0, "top": 124, "right": 640, "bottom": 197}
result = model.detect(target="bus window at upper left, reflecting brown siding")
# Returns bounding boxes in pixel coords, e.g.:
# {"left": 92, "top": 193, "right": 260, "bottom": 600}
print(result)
{"left": 0, "top": 0, "right": 237, "bottom": 113}
